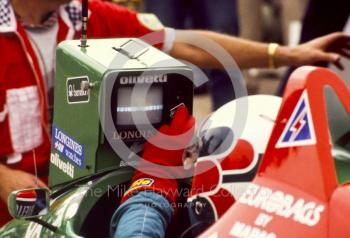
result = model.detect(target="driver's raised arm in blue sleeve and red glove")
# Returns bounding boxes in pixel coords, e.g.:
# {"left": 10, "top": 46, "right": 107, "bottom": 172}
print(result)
{"left": 111, "top": 107, "right": 195, "bottom": 238}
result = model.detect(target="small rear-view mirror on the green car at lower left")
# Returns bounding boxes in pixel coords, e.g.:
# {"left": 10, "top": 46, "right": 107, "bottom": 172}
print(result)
{"left": 8, "top": 188, "right": 49, "bottom": 219}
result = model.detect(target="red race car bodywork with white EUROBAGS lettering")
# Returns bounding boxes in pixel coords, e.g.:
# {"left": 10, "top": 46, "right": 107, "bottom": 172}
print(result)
{"left": 201, "top": 67, "right": 350, "bottom": 238}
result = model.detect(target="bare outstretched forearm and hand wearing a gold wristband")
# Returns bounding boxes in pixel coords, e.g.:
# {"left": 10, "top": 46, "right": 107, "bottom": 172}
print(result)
{"left": 170, "top": 30, "right": 350, "bottom": 68}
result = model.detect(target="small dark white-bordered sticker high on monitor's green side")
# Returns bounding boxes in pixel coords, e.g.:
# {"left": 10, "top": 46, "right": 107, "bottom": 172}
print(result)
{"left": 67, "top": 76, "right": 90, "bottom": 104}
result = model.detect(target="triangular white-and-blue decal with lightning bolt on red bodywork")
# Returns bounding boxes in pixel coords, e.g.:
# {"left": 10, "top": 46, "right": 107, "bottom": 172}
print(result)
{"left": 276, "top": 90, "right": 316, "bottom": 148}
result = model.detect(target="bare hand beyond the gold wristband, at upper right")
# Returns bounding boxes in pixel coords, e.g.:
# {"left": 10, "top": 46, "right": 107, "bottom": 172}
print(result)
{"left": 277, "top": 32, "right": 350, "bottom": 69}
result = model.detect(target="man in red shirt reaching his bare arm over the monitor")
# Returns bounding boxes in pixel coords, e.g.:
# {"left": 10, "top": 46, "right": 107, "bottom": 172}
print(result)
{"left": 0, "top": 0, "right": 350, "bottom": 227}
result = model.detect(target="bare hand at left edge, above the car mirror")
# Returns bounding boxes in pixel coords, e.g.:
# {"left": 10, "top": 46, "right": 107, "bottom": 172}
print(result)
{"left": 0, "top": 165, "right": 47, "bottom": 203}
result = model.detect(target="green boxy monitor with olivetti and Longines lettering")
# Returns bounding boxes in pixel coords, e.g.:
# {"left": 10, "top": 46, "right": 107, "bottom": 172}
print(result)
{"left": 49, "top": 38, "right": 193, "bottom": 186}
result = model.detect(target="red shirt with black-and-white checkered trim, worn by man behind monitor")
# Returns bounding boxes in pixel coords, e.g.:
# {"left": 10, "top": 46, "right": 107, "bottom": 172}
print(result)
{"left": 0, "top": 0, "right": 164, "bottom": 225}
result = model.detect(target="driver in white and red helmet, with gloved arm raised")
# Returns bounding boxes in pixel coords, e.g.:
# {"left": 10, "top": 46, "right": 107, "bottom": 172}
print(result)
{"left": 111, "top": 95, "right": 281, "bottom": 237}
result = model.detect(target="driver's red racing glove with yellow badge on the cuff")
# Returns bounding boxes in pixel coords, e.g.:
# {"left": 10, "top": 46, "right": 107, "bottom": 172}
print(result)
{"left": 122, "top": 107, "right": 195, "bottom": 203}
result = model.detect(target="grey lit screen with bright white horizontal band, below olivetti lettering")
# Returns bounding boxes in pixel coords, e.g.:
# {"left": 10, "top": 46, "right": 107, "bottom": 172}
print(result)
{"left": 116, "top": 86, "right": 163, "bottom": 126}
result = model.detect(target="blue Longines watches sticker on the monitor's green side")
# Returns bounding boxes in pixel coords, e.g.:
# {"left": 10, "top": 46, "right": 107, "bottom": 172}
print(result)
{"left": 52, "top": 126, "right": 85, "bottom": 168}
